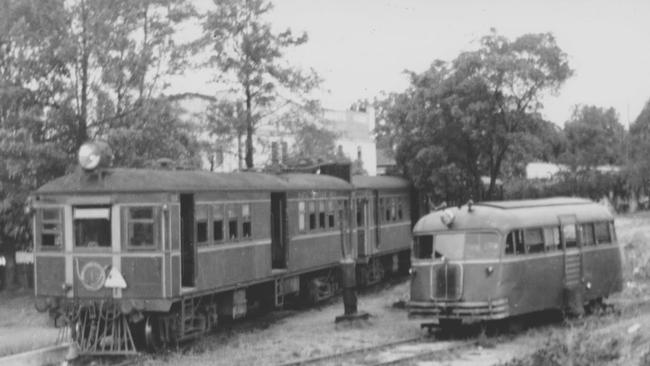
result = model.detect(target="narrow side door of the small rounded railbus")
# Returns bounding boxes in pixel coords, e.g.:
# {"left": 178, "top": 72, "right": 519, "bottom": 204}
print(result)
{"left": 559, "top": 215, "right": 582, "bottom": 289}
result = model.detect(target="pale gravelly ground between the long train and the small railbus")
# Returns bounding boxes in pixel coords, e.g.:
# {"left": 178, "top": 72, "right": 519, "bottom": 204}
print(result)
{"left": 148, "top": 280, "right": 423, "bottom": 365}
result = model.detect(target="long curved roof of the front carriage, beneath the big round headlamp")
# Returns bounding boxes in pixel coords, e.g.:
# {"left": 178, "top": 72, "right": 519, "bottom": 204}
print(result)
{"left": 37, "top": 168, "right": 352, "bottom": 194}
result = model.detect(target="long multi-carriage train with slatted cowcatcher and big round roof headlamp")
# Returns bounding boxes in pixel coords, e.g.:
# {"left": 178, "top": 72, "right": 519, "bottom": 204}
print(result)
{"left": 31, "top": 142, "right": 411, "bottom": 354}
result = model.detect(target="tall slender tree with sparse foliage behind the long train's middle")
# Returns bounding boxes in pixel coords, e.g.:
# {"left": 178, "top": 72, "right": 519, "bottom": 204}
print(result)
{"left": 196, "top": 0, "right": 319, "bottom": 168}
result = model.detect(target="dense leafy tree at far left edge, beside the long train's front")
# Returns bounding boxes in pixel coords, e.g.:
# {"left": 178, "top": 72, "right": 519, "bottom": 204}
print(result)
{"left": 0, "top": 0, "right": 67, "bottom": 288}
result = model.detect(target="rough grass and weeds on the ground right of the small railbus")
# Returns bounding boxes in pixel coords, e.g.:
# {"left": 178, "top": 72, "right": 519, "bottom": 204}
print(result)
{"left": 502, "top": 212, "right": 650, "bottom": 366}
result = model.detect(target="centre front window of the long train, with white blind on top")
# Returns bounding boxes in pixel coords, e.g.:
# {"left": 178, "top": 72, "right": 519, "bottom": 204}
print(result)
{"left": 73, "top": 207, "right": 111, "bottom": 248}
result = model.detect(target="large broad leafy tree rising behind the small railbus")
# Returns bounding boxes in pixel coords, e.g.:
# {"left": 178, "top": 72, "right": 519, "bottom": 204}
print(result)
{"left": 379, "top": 32, "right": 572, "bottom": 203}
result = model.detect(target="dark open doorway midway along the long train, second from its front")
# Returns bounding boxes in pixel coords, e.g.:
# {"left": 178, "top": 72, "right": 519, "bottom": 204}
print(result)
{"left": 271, "top": 192, "right": 287, "bottom": 269}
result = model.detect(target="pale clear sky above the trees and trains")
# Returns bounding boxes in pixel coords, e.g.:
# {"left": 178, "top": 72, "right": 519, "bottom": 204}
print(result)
{"left": 172, "top": 0, "right": 650, "bottom": 126}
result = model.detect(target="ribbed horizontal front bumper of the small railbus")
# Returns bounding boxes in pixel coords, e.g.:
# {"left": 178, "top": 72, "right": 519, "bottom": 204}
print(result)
{"left": 406, "top": 298, "right": 510, "bottom": 321}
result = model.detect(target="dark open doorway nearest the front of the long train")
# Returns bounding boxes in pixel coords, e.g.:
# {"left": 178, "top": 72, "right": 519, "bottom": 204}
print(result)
{"left": 180, "top": 194, "right": 196, "bottom": 287}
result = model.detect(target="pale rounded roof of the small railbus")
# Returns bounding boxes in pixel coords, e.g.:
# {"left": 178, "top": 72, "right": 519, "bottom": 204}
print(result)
{"left": 413, "top": 197, "right": 613, "bottom": 234}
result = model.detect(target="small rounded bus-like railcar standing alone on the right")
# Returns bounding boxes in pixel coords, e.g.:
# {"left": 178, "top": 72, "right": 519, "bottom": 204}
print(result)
{"left": 407, "top": 198, "right": 623, "bottom": 327}
